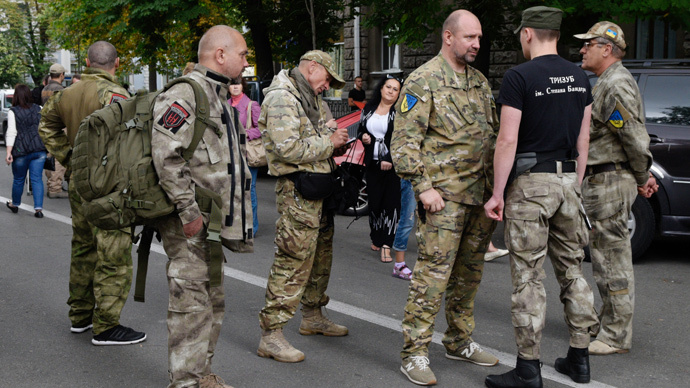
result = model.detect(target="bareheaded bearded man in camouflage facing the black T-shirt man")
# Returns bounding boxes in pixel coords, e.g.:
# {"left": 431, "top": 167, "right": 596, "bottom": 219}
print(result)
{"left": 391, "top": 10, "right": 498, "bottom": 385}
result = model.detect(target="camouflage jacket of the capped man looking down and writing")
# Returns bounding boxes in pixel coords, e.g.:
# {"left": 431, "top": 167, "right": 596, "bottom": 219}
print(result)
{"left": 259, "top": 70, "right": 335, "bottom": 176}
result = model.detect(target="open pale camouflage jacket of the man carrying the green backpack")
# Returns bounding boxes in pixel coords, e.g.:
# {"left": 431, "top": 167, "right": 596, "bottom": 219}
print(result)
{"left": 150, "top": 64, "right": 252, "bottom": 247}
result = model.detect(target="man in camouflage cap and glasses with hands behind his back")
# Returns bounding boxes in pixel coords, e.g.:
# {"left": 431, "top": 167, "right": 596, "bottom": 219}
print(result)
{"left": 575, "top": 21, "right": 659, "bottom": 355}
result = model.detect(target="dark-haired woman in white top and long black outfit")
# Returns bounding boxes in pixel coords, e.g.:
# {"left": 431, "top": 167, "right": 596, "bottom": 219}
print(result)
{"left": 358, "top": 75, "right": 402, "bottom": 263}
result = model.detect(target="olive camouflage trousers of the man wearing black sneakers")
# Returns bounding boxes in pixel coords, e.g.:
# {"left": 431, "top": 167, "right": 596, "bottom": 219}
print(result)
{"left": 67, "top": 181, "right": 132, "bottom": 335}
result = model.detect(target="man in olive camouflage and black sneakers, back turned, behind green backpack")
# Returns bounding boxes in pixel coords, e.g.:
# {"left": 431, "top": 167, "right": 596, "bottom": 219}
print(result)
{"left": 38, "top": 41, "right": 146, "bottom": 345}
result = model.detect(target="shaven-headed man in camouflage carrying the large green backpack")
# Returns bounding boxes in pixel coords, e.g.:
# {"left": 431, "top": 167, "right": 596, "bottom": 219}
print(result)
{"left": 151, "top": 25, "right": 253, "bottom": 388}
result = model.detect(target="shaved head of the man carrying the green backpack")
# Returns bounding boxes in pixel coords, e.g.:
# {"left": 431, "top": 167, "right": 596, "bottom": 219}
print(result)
{"left": 198, "top": 25, "right": 249, "bottom": 78}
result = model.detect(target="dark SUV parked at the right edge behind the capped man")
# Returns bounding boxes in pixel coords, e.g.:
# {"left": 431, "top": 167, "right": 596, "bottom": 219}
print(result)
{"left": 590, "top": 59, "right": 690, "bottom": 260}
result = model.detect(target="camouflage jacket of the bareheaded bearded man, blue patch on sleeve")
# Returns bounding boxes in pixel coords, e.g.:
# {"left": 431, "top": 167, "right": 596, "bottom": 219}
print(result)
{"left": 391, "top": 54, "right": 499, "bottom": 205}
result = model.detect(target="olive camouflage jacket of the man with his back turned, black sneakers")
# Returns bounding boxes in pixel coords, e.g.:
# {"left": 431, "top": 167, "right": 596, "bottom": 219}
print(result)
{"left": 38, "top": 67, "right": 129, "bottom": 166}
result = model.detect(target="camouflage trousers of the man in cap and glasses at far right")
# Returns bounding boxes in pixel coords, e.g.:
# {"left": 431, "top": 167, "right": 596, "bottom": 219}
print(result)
{"left": 582, "top": 170, "right": 637, "bottom": 349}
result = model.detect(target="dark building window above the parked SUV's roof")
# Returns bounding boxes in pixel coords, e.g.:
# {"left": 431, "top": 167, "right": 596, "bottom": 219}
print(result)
{"left": 635, "top": 19, "right": 678, "bottom": 59}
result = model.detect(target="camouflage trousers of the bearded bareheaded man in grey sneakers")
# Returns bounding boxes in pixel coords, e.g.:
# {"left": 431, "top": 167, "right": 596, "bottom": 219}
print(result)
{"left": 401, "top": 201, "right": 496, "bottom": 359}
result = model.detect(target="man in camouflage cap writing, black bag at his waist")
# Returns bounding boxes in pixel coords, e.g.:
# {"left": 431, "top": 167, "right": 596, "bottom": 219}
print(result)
{"left": 257, "top": 50, "right": 348, "bottom": 362}
